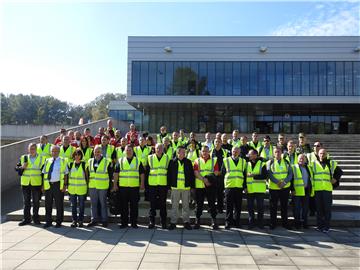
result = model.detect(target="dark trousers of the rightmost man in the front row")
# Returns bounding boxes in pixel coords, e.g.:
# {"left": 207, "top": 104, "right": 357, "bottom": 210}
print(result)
{"left": 315, "top": 190, "right": 332, "bottom": 230}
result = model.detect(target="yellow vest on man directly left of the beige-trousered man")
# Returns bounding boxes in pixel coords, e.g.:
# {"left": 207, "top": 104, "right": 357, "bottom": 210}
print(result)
{"left": 148, "top": 154, "right": 169, "bottom": 186}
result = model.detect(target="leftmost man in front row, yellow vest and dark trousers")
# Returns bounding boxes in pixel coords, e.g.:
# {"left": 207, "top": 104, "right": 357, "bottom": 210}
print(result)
{"left": 17, "top": 143, "right": 45, "bottom": 226}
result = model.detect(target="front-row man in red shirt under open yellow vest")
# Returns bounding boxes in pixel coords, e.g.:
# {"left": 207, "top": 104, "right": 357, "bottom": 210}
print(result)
{"left": 194, "top": 146, "right": 220, "bottom": 230}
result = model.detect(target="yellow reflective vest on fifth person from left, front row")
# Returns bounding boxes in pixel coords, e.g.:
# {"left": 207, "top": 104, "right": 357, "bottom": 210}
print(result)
{"left": 119, "top": 157, "right": 140, "bottom": 187}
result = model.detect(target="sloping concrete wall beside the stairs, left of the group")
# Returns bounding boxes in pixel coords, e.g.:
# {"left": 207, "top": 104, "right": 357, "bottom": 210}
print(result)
{"left": 0, "top": 118, "right": 129, "bottom": 192}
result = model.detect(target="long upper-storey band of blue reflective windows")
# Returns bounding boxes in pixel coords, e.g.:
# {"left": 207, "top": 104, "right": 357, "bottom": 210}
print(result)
{"left": 131, "top": 61, "right": 360, "bottom": 96}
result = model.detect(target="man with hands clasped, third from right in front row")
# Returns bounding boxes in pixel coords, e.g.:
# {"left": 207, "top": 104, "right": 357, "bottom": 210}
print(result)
{"left": 266, "top": 147, "right": 293, "bottom": 230}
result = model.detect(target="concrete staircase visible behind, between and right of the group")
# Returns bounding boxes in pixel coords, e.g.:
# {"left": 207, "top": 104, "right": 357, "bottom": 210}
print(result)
{"left": 6, "top": 135, "right": 360, "bottom": 227}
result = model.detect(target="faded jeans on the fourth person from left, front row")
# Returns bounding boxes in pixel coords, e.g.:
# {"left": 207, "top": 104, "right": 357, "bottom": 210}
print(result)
{"left": 89, "top": 188, "right": 108, "bottom": 222}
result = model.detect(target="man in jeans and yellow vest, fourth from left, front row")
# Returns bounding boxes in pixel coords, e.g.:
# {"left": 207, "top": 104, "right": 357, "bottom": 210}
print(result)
{"left": 87, "top": 144, "right": 119, "bottom": 228}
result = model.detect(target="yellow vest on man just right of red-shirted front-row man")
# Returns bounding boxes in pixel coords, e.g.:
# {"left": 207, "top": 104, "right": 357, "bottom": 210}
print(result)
{"left": 224, "top": 157, "right": 246, "bottom": 188}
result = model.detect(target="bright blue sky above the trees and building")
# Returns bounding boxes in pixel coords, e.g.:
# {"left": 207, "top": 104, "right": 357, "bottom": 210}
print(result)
{"left": 0, "top": 0, "right": 360, "bottom": 105}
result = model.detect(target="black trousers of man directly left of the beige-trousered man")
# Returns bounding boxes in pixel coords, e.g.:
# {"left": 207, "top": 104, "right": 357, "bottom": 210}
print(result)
{"left": 149, "top": 186, "right": 168, "bottom": 223}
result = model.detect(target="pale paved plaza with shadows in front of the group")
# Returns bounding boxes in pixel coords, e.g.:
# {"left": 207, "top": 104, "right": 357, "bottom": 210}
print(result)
{"left": 1, "top": 221, "right": 360, "bottom": 270}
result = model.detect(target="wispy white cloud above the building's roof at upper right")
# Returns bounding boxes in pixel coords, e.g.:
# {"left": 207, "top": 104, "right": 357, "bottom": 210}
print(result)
{"left": 270, "top": 2, "right": 360, "bottom": 36}
